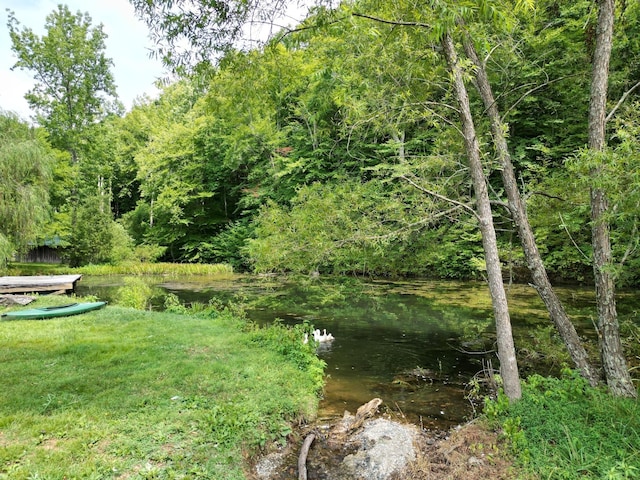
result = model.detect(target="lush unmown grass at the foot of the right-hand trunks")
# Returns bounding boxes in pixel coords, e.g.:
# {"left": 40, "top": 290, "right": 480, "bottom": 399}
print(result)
{"left": 487, "top": 371, "right": 640, "bottom": 479}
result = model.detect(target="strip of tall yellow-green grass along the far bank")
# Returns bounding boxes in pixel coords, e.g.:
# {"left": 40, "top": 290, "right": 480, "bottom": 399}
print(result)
{"left": 6, "top": 262, "right": 233, "bottom": 276}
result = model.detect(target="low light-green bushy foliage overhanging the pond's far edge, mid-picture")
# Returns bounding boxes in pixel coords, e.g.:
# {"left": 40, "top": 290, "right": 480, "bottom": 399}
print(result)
{"left": 247, "top": 181, "right": 482, "bottom": 278}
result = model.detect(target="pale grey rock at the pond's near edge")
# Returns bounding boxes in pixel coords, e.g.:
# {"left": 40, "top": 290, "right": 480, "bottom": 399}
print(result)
{"left": 340, "top": 418, "right": 418, "bottom": 480}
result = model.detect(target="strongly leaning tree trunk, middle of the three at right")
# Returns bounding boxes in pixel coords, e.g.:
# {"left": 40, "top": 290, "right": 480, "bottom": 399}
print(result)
{"left": 464, "top": 37, "right": 599, "bottom": 387}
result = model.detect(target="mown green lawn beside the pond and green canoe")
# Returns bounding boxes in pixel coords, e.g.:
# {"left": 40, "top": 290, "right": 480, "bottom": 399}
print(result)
{"left": 0, "top": 298, "right": 323, "bottom": 480}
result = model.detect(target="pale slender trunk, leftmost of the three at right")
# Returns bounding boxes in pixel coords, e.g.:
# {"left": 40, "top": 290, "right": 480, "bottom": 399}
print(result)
{"left": 442, "top": 33, "right": 522, "bottom": 400}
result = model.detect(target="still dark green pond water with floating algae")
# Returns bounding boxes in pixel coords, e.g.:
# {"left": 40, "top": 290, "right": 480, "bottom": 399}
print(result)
{"left": 77, "top": 275, "right": 620, "bottom": 428}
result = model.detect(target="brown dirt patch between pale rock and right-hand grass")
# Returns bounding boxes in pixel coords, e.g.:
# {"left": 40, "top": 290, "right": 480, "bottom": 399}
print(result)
{"left": 394, "top": 421, "right": 517, "bottom": 480}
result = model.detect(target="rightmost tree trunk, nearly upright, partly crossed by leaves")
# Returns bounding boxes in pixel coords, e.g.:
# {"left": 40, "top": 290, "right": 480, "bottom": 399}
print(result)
{"left": 589, "top": 0, "right": 637, "bottom": 397}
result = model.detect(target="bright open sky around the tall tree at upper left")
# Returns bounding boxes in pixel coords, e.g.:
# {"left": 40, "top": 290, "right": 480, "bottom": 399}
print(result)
{"left": 0, "top": 0, "right": 167, "bottom": 120}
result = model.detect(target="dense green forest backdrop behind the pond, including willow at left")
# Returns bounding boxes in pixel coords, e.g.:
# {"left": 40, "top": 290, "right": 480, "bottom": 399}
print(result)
{"left": 0, "top": 0, "right": 640, "bottom": 285}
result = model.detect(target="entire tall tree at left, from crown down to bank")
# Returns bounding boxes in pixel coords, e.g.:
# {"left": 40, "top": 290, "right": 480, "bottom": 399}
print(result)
{"left": 7, "top": 5, "right": 118, "bottom": 265}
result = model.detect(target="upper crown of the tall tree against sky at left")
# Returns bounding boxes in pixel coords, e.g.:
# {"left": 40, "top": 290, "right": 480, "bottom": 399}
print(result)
{"left": 7, "top": 5, "right": 116, "bottom": 163}
